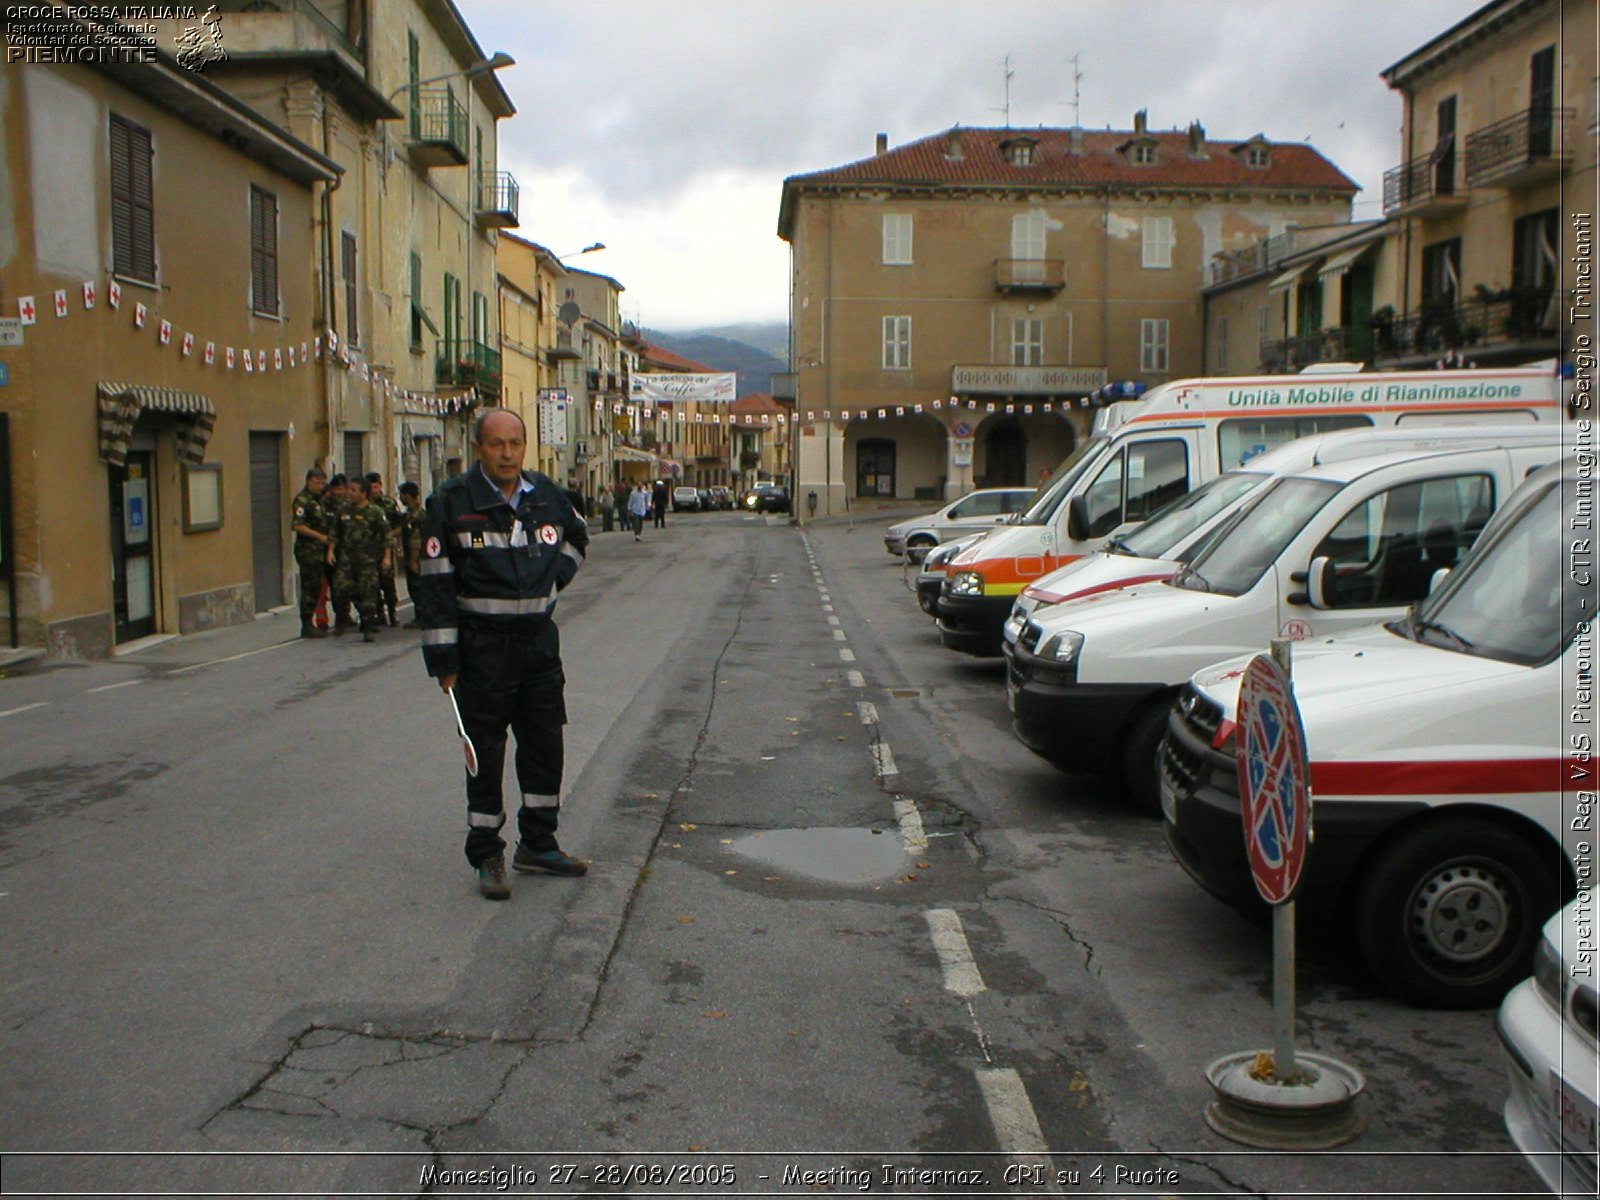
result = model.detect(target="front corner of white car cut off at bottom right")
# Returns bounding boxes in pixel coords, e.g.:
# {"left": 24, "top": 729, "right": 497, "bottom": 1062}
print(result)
{"left": 1496, "top": 899, "right": 1600, "bottom": 1197}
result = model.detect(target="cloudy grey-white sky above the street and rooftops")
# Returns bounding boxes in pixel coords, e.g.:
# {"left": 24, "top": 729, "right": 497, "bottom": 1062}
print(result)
{"left": 458, "top": 0, "right": 1482, "bottom": 330}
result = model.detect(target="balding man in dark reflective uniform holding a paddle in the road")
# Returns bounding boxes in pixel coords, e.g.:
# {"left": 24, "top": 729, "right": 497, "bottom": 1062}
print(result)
{"left": 416, "top": 408, "right": 589, "bottom": 899}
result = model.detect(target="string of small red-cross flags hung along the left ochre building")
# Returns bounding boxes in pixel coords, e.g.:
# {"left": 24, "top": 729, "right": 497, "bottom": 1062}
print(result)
{"left": 16, "top": 278, "right": 478, "bottom": 416}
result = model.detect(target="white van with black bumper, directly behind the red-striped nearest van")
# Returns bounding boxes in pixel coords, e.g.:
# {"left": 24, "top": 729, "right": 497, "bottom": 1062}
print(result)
{"left": 1006, "top": 438, "right": 1562, "bottom": 810}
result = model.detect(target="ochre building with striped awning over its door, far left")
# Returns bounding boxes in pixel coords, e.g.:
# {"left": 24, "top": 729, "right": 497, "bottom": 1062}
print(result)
{"left": 0, "top": 23, "right": 341, "bottom": 658}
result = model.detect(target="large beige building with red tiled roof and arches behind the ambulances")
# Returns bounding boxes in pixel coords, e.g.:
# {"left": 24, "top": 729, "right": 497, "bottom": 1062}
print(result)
{"left": 778, "top": 122, "right": 1357, "bottom": 515}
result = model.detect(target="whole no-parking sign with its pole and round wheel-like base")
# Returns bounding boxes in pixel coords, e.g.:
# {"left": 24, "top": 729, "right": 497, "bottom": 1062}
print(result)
{"left": 1205, "top": 638, "right": 1366, "bottom": 1149}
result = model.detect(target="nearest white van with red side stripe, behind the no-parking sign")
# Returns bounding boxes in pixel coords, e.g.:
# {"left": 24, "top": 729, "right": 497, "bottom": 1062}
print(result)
{"left": 1160, "top": 458, "right": 1597, "bottom": 1006}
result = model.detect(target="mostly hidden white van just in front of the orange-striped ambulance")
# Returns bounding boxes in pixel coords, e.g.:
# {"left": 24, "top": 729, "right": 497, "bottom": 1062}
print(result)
{"left": 1002, "top": 424, "right": 1574, "bottom": 645}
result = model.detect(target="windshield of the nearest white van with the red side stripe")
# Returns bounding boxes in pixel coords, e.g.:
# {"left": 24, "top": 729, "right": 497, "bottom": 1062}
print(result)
{"left": 1390, "top": 475, "right": 1594, "bottom": 666}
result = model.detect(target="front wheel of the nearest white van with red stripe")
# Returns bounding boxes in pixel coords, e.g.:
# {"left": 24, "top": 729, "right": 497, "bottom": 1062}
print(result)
{"left": 1356, "top": 818, "right": 1560, "bottom": 1008}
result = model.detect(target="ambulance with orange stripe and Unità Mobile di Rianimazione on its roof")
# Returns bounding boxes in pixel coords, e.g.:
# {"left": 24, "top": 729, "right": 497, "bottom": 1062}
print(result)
{"left": 939, "top": 362, "right": 1562, "bottom": 654}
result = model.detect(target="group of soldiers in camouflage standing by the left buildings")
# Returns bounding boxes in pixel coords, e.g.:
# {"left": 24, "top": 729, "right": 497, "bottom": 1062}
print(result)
{"left": 290, "top": 467, "right": 422, "bottom": 642}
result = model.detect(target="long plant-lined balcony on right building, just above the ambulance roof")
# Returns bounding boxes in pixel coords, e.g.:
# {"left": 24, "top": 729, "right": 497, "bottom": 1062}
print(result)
{"left": 1371, "top": 288, "right": 1562, "bottom": 366}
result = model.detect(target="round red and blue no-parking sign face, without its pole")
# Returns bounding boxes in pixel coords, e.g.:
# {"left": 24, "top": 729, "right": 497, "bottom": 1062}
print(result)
{"left": 1238, "top": 654, "right": 1310, "bottom": 904}
